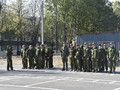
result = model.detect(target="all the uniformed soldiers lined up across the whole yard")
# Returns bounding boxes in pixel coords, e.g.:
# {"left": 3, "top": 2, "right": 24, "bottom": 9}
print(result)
{"left": 6, "top": 42, "right": 120, "bottom": 73}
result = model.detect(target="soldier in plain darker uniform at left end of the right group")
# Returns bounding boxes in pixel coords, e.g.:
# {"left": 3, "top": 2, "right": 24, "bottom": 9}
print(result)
{"left": 60, "top": 43, "right": 69, "bottom": 71}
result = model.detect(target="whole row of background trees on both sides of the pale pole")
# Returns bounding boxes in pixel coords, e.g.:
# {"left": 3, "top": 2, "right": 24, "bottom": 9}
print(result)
{"left": 0, "top": 0, "right": 120, "bottom": 49}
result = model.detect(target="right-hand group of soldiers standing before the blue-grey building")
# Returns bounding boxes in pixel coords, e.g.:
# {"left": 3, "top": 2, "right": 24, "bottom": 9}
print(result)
{"left": 61, "top": 42, "right": 116, "bottom": 73}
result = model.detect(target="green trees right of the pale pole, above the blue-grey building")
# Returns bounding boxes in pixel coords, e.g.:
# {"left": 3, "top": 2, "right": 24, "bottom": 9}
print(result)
{"left": 45, "top": 0, "right": 120, "bottom": 46}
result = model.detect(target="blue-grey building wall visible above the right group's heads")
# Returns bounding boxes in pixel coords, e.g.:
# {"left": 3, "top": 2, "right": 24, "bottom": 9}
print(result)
{"left": 76, "top": 32, "right": 120, "bottom": 50}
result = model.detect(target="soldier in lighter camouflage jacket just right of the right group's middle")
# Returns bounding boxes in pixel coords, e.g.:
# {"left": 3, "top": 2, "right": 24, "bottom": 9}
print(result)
{"left": 91, "top": 43, "right": 99, "bottom": 72}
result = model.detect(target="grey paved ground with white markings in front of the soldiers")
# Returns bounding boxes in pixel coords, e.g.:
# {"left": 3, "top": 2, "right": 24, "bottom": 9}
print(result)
{"left": 0, "top": 65, "right": 120, "bottom": 90}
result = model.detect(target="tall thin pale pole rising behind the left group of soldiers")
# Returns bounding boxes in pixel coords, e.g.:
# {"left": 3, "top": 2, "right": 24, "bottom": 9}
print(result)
{"left": 41, "top": 1, "right": 44, "bottom": 44}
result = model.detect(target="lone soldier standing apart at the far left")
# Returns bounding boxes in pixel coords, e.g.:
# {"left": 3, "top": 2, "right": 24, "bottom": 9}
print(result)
{"left": 6, "top": 45, "right": 13, "bottom": 71}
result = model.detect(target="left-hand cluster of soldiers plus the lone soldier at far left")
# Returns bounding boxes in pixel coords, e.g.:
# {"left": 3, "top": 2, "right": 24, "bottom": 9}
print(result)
{"left": 6, "top": 44, "right": 54, "bottom": 71}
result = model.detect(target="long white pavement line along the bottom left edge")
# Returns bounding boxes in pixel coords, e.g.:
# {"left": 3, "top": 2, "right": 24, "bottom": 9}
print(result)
{"left": 0, "top": 84, "right": 62, "bottom": 90}
